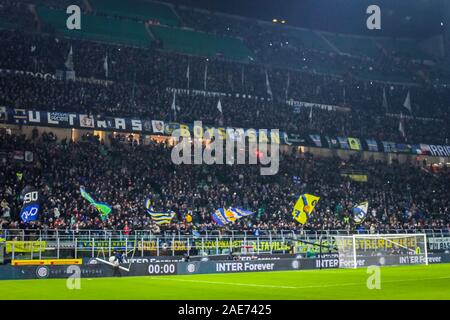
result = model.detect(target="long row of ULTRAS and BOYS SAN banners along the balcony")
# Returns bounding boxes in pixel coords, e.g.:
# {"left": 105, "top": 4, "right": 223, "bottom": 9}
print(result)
{"left": 0, "top": 104, "right": 450, "bottom": 157}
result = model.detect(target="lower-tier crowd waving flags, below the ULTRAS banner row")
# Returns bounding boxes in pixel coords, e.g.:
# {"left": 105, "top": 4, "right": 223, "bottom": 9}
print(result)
{"left": 0, "top": 132, "right": 450, "bottom": 233}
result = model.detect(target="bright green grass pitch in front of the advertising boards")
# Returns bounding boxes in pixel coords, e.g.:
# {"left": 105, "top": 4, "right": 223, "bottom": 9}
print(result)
{"left": 1, "top": 264, "right": 450, "bottom": 300}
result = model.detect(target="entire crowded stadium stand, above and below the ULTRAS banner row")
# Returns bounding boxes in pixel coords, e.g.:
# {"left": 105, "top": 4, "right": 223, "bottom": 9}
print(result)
{"left": 0, "top": 0, "right": 450, "bottom": 232}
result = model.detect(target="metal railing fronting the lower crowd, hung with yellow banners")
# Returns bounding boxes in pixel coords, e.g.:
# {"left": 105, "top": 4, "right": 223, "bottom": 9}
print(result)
{"left": 0, "top": 229, "right": 450, "bottom": 260}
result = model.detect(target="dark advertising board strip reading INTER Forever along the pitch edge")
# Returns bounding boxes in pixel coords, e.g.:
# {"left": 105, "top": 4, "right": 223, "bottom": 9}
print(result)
{"left": 0, "top": 253, "right": 450, "bottom": 280}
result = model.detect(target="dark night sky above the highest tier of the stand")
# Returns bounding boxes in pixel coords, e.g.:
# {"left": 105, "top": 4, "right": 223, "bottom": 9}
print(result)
{"left": 165, "top": 0, "right": 442, "bottom": 38}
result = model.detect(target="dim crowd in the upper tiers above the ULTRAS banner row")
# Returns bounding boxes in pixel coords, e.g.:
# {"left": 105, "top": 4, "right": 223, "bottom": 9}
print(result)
{"left": 0, "top": 31, "right": 450, "bottom": 144}
